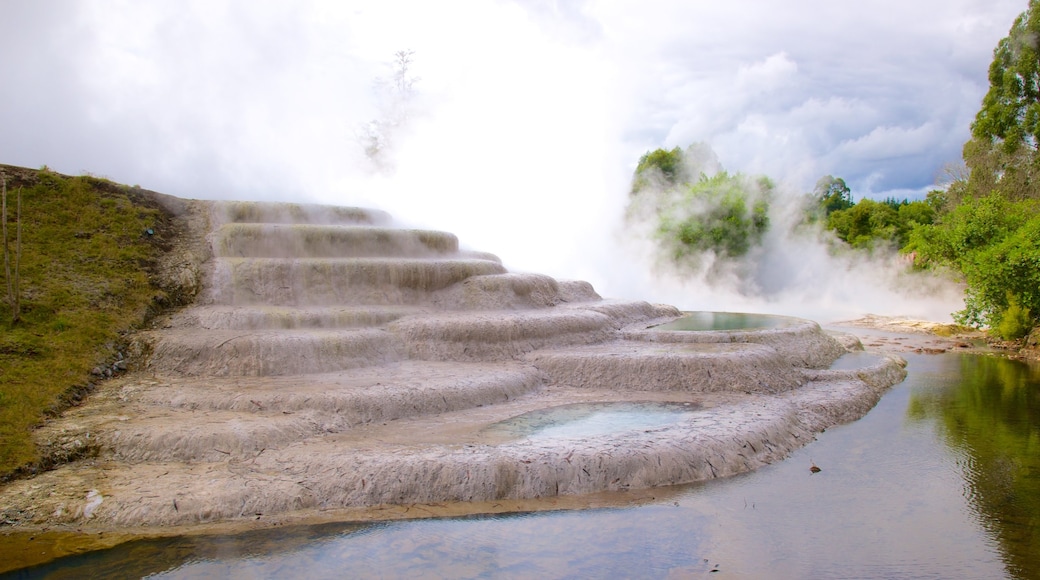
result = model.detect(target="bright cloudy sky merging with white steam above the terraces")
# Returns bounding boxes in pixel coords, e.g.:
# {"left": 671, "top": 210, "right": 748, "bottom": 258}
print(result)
{"left": 0, "top": 0, "right": 1028, "bottom": 318}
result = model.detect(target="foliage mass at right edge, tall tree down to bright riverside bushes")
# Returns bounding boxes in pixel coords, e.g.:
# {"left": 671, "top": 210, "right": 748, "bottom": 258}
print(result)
{"left": 923, "top": 0, "right": 1040, "bottom": 338}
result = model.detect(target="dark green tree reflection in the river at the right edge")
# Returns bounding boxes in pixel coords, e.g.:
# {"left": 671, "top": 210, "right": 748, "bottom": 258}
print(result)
{"left": 908, "top": 357, "right": 1040, "bottom": 578}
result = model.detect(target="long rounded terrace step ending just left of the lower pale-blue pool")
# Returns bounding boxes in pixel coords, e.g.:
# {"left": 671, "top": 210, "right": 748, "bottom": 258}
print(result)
{"left": 105, "top": 362, "right": 544, "bottom": 462}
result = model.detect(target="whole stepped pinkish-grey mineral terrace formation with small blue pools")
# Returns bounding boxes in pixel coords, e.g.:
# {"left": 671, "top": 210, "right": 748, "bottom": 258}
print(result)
{"left": 0, "top": 200, "right": 905, "bottom": 527}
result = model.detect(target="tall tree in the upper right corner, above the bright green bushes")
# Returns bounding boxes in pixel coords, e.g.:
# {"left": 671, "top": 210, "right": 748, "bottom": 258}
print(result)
{"left": 964, "top": 0, "right": 1040, "bottom": 200}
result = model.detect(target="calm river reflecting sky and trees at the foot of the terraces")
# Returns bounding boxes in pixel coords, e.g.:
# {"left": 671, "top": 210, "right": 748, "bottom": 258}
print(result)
{"left": 11, "top": 354, "right": 1040, "bottom": 578}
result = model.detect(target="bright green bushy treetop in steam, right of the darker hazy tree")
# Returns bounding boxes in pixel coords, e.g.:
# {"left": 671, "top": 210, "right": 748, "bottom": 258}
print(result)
{"left": 657, "top": 172, "right": 774, "bottom": 260}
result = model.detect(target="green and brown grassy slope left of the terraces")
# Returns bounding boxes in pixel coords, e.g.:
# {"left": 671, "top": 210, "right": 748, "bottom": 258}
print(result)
{"left": 0, "top": 166, "right": 174, "bottom": 478}
